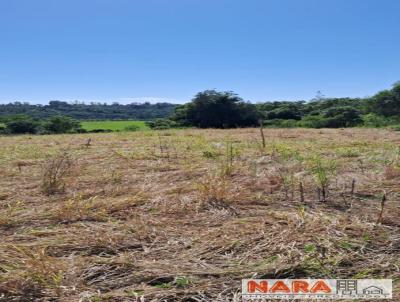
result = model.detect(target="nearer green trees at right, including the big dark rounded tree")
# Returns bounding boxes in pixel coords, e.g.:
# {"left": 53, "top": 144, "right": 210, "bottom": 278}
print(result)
{"left": 163, "top": 82, "right": 400, "bottom": 128}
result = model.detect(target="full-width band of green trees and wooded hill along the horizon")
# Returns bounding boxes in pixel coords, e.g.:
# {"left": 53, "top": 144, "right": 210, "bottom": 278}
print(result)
{"left": 0, "top": 82, "right": 400, "bottom": 134}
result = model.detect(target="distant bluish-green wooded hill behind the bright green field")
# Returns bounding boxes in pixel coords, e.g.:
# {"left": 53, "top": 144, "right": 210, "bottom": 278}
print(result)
{"left": 0, "top": 101, "right": 177, "bottom": 120}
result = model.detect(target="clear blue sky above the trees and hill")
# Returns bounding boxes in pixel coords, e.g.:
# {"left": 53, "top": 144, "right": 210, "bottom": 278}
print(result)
{"left": 0, "top": 0, "right": 400, "bottom": 103}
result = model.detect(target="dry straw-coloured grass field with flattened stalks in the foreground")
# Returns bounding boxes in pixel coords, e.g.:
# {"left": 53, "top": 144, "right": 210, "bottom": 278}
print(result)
{"left": 0, "top": 129, "right": 400, "bottom": 301}
